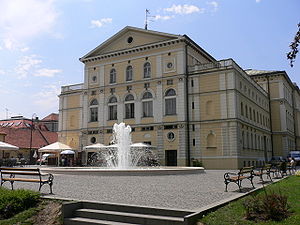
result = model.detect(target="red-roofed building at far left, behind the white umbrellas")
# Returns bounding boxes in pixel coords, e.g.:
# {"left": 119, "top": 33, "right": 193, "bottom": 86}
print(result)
{"left": 0, "top": 116, "right": 57, "bottom": 162}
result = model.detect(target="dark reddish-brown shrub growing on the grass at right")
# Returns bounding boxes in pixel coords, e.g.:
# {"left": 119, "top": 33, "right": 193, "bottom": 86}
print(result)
{"left": 243, "top": 188, "right": 290, "bottom": 221}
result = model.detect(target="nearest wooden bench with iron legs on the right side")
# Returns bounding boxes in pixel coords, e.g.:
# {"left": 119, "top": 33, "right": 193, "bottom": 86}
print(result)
{"left": 224, "top": 166, "right": 255, "bottom": 192}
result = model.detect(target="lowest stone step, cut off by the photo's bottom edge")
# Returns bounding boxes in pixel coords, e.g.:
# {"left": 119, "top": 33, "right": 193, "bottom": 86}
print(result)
{"left": 64, "top": 217, "right": 139, "bottom": 225}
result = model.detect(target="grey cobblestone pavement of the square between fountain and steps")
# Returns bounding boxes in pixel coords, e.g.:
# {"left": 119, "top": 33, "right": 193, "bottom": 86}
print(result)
{"left": 4, "top": 170, "right": 274, "bottom": 210}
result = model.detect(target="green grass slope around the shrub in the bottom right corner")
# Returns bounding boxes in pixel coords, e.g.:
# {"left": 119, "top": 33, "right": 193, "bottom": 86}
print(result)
{"left": 199, "top": 176, "right": 300, "bottom": 225}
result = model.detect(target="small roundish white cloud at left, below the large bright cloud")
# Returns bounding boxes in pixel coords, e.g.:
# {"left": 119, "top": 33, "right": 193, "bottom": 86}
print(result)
{"left": 15, "top": 55, "right": 42, "bottom": 79}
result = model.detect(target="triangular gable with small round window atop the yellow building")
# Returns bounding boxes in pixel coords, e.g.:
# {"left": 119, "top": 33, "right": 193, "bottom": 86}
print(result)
{"left": 81, "top": 26, "right": 182, "bottom": 60}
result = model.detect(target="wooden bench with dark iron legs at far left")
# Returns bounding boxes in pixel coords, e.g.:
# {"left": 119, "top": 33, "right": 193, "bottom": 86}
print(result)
{"left": 0, "top": 167, "right": 54, "bottom": 194}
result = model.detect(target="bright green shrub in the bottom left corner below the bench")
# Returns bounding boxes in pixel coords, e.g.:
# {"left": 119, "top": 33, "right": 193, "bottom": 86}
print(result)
{"left": 0, "top": 188, "right": 40, "bottom": 220}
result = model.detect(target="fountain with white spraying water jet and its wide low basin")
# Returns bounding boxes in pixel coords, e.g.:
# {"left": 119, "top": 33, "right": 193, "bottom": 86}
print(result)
{"left": 42, "top": 123, "right": 204, "bottom": 176}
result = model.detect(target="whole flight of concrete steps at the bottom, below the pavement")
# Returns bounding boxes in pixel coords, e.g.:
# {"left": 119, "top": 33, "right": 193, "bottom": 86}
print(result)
{"left": 63, "top": 202, "right": 193, "bottom": 225}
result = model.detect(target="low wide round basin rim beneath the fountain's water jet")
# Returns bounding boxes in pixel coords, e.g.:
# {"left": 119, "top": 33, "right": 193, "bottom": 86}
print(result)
{"left": 40, "top": 167, "right": 204, "bottom": 176}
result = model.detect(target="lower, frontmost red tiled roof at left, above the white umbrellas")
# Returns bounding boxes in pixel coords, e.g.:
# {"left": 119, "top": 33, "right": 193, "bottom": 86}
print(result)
{"left": 0, "top": 127, "right": 58, "bottom": 149}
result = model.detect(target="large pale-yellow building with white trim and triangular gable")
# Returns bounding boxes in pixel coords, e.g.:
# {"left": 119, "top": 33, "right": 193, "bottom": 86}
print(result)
{"left": 59, "top": 27, "right": 300, "bottom": 169}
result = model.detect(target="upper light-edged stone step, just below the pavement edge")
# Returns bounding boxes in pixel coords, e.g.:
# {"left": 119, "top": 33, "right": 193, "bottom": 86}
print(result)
{"left": 75, "top": 208, "right": 184, "bottom": 225}
